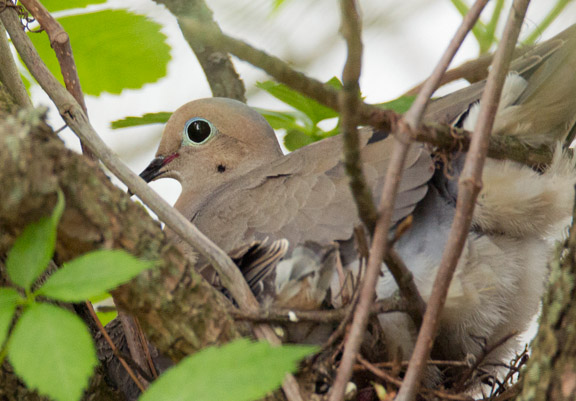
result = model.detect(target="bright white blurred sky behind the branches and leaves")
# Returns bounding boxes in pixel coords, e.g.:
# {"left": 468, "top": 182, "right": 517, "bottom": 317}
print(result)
{"left": 33, "top": 0, "right": 576, "bottom": 202}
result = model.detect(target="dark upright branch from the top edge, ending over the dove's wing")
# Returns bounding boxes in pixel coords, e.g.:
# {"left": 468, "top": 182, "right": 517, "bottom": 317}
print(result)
{"left": 339, "top": 0, "right": 378, "bottom": 232}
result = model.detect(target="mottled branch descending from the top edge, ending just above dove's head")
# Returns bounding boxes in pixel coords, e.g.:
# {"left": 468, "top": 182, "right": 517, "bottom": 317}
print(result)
{"left": 155, "top": 0, "right": 246, "bottom": 103}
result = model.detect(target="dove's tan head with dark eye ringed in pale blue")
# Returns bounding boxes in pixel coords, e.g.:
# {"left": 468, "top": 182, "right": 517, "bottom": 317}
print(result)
{"left": 140, "top": 98, "right": 282, "bottom": 192}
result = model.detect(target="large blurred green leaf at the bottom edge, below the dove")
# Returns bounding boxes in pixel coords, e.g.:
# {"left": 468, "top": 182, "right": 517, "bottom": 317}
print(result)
{"left": 140, "top": 339, "right": 316, "bottom": 401}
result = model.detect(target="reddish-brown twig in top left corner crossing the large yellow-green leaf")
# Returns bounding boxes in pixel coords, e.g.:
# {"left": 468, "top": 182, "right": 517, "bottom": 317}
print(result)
{"left": 20, "top": 0, "right": 96, "bottom": 160}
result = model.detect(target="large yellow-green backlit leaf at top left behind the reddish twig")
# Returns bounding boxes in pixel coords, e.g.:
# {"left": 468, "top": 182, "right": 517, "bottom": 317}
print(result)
{"left": 30, "top": 10, "right": 170, "bottom": 96}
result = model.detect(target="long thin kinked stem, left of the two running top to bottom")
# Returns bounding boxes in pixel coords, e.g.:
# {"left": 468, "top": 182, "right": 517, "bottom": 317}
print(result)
{"left": 330, "top": 0, "right": 487, "bottom": 401}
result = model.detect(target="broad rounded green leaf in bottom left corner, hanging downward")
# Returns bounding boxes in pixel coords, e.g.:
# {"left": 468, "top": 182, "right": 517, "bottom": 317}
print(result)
{"left": 8, "top": 304, "right": 98, "bottom": 401}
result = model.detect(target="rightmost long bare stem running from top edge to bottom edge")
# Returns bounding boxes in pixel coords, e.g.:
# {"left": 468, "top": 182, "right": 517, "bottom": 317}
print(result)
{"left": 397, "top": 0, "right": 529, "bottom": 401}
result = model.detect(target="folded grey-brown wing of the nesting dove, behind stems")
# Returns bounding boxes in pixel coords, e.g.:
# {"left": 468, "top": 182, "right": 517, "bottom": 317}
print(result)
{"left": 191, "top": 130, "right": 433, "bottom": 250}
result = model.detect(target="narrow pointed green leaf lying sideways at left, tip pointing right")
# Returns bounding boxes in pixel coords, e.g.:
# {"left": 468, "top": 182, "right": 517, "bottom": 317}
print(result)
{"left": 38, "top": 250, "right": 154, "bottom": 302}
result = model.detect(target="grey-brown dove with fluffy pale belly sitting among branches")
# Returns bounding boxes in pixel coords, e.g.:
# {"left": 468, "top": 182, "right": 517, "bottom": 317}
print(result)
{"left": 140, "top": 25, "right": 576, "bottom": 390}
